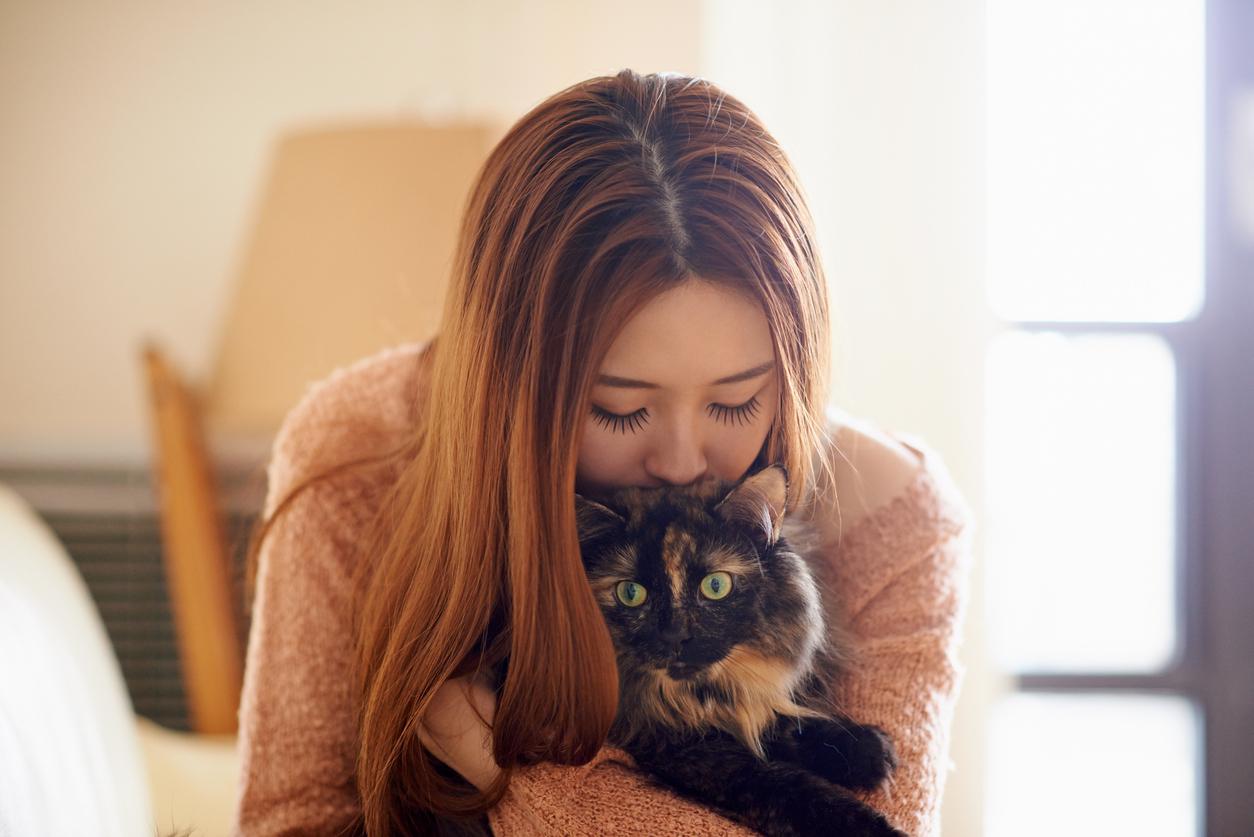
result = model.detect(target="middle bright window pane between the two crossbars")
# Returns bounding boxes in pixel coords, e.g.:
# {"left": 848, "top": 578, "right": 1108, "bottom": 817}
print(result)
{"left": 986, "top": 331, "right": 1175, "bottom": 671}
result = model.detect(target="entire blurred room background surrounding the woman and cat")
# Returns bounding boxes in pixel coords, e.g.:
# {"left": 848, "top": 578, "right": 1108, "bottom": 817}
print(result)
{"left": 0, "top": 0, "right": 1254, "bottom": 836}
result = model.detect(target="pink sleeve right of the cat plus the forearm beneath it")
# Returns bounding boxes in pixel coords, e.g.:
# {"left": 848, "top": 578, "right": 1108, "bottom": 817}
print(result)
{"left": 489, "top": 435, "right": 972, "bottom": 837}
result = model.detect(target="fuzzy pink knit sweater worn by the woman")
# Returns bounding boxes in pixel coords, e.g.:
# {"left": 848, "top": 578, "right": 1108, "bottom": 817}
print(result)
{"left": 233, "top": 341, "right": 972, "bottom": 837}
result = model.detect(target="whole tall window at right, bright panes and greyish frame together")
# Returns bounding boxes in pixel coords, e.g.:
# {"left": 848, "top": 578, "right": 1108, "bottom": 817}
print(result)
{"left": 984, "top": 0, "right": 1254, "bottom": 837}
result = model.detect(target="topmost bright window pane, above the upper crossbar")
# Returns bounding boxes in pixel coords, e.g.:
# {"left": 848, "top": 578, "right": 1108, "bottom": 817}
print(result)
{"left": 986, "top": 0, "right": 1205, "bottom": 321}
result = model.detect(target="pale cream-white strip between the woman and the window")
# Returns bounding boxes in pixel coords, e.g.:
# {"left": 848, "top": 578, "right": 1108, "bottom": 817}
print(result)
{"left": 703, "top": 0, "right": 1006, "bottom": 834}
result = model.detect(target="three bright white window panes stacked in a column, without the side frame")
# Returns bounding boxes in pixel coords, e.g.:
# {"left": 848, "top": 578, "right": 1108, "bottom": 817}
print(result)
{"left": 984, "top": 0, "right": 1206, "bottom": 837}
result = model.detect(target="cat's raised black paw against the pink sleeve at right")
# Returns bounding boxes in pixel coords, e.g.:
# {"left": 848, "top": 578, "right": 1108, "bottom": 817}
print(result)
{"left": 793, "top": 719, "right": 897, "bottom": 791}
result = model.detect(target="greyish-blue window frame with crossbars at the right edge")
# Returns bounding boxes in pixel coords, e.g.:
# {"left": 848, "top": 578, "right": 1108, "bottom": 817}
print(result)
{"left": 988, "top": 0, "right": 1254, "bottom": 834}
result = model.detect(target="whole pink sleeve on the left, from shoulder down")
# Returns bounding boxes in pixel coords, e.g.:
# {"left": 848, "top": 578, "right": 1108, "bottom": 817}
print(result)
{"left": 232, "top": 341, "right": 428, "bottom": 837}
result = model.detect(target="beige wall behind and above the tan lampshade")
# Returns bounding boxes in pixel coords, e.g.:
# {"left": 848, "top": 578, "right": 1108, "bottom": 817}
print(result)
{"left": 0, "top": 0, "right": 700, "bottom": 462}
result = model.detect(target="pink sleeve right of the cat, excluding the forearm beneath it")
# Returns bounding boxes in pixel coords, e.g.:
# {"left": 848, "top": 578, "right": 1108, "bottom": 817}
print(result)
{"left": 828, "top": 434, "right": 973, "bottom": 837}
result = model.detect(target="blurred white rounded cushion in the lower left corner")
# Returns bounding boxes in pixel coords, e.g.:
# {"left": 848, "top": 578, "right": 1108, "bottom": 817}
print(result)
{"left": 0, "top": 484, "right": 153, "bottom": 837}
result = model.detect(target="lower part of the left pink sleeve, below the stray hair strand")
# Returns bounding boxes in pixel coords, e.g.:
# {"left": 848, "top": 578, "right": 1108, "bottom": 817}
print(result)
{"left": 232, "top": 474, "right": 360, "bottom": 837}
